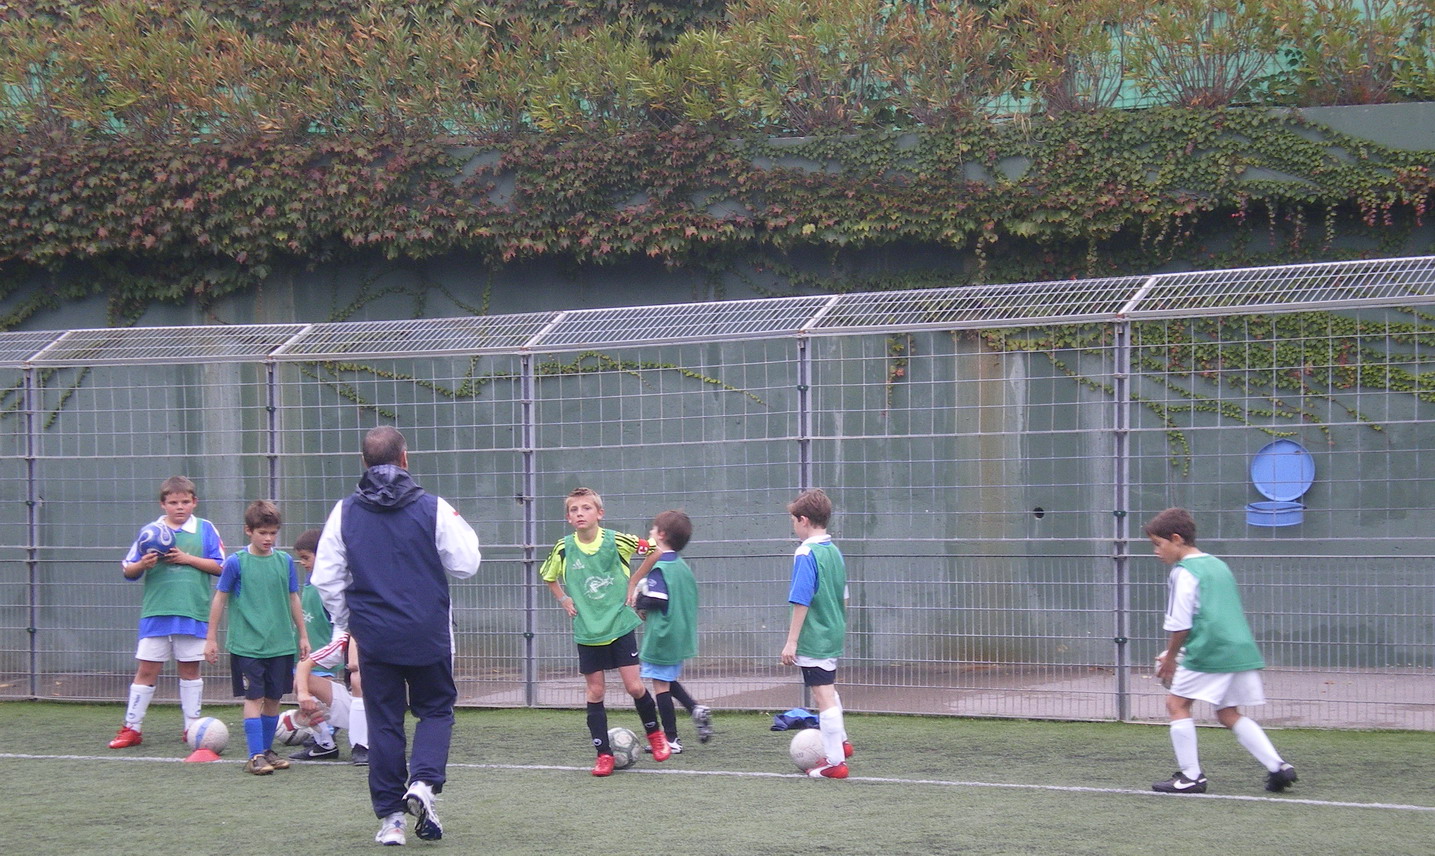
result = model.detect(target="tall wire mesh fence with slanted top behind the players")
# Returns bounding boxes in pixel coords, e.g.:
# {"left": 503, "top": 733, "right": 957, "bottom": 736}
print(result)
{"left": 0, "top": 258, "right": 1435, "bottom": 730}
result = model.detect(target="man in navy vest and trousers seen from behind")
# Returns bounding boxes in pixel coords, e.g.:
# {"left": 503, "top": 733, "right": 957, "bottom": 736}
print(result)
{"left": 310, "top": 426, "right": 481, "bottom": 845}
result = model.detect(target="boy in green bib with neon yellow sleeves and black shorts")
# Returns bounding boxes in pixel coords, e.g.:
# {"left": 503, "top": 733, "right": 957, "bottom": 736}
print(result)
{"left": 538, "top": 488, "right": 670, "bottom": 776}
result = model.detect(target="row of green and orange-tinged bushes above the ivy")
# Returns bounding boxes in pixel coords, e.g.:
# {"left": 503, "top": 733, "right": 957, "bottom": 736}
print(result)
{"left": 8, "top": 0, "right": 1435, "bottom": 139}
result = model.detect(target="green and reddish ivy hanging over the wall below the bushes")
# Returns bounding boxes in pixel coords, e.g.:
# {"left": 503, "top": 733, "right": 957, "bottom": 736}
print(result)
{"left": 0, "top": 108, "right": 1435, "bottom": 327}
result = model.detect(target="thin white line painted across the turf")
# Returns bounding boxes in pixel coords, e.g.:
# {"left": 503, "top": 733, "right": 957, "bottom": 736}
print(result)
{"left": 11, "top": 753, "right": 1435, "bottom": 812}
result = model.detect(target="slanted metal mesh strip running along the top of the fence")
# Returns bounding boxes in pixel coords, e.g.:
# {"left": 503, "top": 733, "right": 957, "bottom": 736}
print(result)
{"left": 0, "top": 250, "right": 1435, "bottom": 368}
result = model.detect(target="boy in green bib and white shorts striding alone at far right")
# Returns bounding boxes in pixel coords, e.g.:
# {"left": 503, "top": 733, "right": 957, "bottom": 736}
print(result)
{"left": 1144, "top": 508, "right": 1296, "bottom": 793}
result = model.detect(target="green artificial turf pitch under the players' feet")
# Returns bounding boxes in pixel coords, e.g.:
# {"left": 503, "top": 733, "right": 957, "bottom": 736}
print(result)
{"left": 0, "top": 701, "right": 1435, "bottom": 856}
